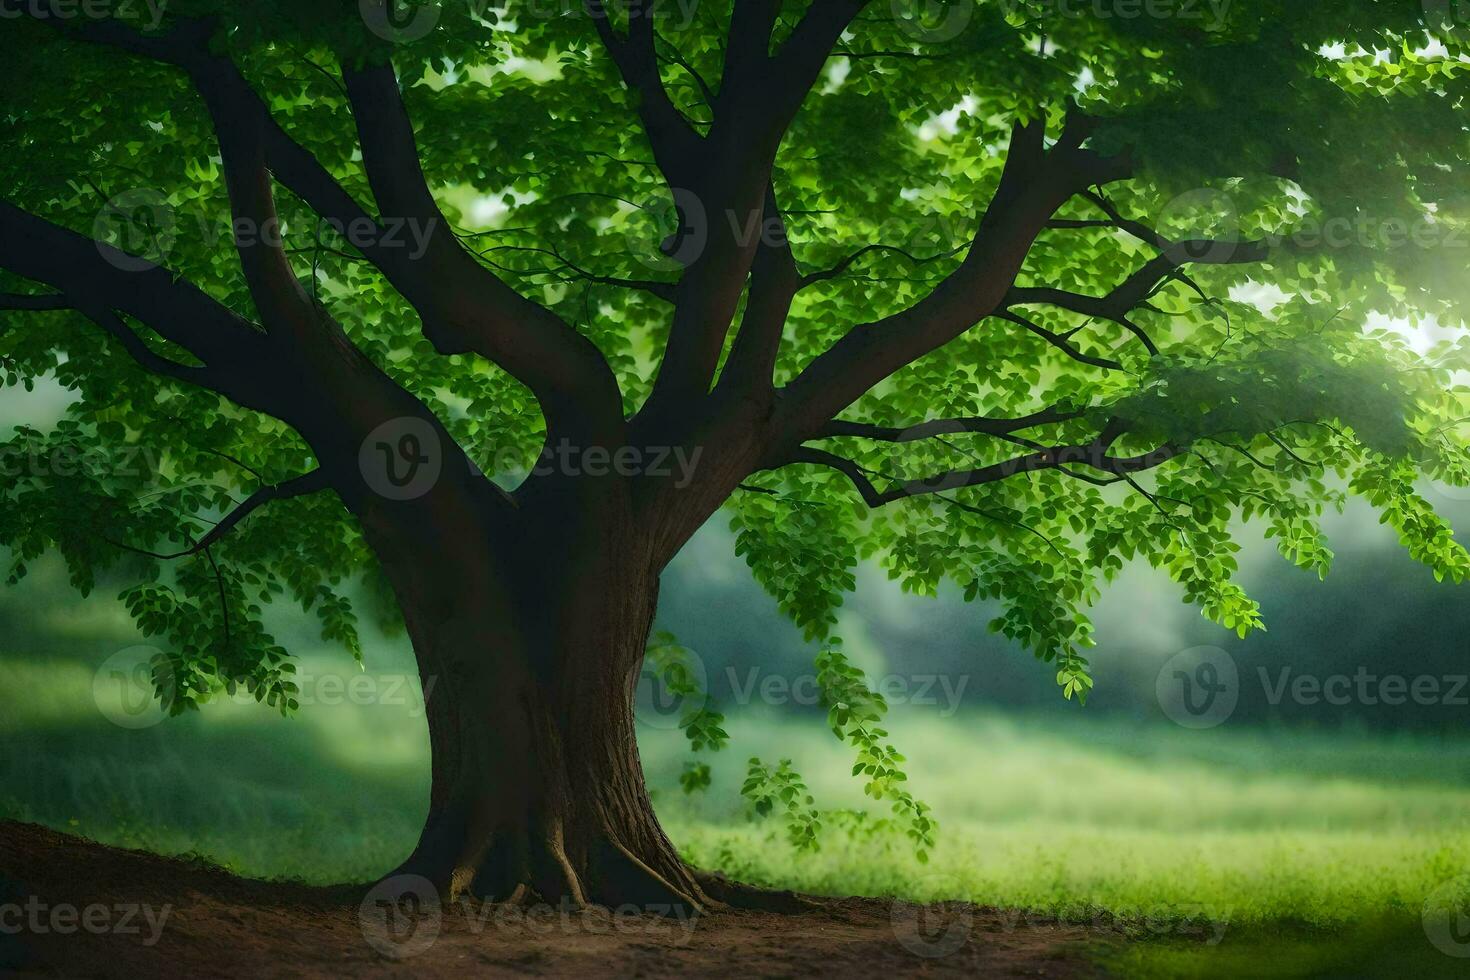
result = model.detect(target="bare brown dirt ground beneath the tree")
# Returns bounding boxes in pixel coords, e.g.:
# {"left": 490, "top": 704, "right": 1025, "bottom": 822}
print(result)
{"left": 0, "top": 823, "right": 1103, "bottom": 977}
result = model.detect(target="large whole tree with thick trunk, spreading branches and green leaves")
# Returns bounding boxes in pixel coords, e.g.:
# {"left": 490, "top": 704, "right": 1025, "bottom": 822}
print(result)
{"left": 0, "top": 0, "right": 1470, "bottom": 905}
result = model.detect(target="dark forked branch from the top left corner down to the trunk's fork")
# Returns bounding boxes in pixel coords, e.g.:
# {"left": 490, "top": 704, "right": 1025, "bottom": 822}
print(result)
{"left": 14, "top": 10, "right": 622, "bottom": 436}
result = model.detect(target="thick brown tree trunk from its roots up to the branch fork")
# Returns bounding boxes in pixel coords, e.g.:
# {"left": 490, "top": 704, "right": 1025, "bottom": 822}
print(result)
{"left": 355, "top": 493, "right": 719, "bottom": 914}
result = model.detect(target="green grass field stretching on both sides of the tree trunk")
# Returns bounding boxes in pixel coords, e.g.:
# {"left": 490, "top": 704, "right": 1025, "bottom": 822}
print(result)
{"left": 0, "top": 646, "right": 1470, "bottom": 977}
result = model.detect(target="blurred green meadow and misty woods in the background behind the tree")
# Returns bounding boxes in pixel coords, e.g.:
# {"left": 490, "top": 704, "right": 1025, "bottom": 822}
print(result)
{"left": 0, "top": 373, "right": 1470, "bottom": 976}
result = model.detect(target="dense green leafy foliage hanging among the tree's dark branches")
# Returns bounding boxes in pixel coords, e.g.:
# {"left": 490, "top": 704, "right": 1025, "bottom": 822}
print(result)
{"left": 0, "top": 0, "right": 1470, "bottom": 842}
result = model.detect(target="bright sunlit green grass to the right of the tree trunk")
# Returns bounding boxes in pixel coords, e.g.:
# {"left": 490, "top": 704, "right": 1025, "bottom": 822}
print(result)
{"left": 652, "top": 716, "right": 1470, "bottom": 977}
